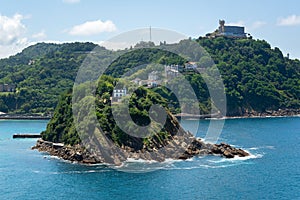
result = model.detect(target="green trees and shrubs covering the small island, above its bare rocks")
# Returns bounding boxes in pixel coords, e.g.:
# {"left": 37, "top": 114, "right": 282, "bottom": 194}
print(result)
{"left": 41, "top": 75, "right": 176, "bottom": 150}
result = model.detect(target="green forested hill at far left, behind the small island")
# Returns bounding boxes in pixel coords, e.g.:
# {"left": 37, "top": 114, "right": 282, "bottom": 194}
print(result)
{"left": 0, "top": 43, "right": 96, "bottom": 114}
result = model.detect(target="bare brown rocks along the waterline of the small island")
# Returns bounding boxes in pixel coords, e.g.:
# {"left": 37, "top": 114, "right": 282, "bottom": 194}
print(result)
{"left": 32, "top": 138, "right": 249, "bottom": 165}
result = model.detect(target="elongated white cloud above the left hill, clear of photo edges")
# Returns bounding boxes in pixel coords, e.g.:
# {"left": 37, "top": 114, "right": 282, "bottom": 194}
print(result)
{"left": 68, "top": 20, "right": 117, "bottom": 36}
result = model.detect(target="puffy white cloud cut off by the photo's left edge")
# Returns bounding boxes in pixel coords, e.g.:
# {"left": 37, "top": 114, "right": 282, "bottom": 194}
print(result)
{"left": 0, "top": 14, "right": 26, "bottom": 45}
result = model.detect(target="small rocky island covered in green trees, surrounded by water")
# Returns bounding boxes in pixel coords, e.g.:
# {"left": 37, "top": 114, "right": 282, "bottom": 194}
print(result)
{"left": 39, "top": 76, "right": 249, "bottom": 165}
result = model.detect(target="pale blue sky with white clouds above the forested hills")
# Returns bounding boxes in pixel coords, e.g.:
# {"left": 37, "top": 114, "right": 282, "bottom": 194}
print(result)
{"left": 0, "top": 0, "right": 300, "bottom": 58}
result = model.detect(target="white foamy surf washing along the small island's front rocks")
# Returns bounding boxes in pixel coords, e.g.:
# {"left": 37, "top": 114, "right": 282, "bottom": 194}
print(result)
{"left": 40, "top": 146, "right": 264, "bottom": 174}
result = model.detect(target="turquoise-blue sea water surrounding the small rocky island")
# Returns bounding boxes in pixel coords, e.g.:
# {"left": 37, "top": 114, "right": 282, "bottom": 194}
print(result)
{"left": 0, "top": 117, "right": 300, "bottom": 199}
